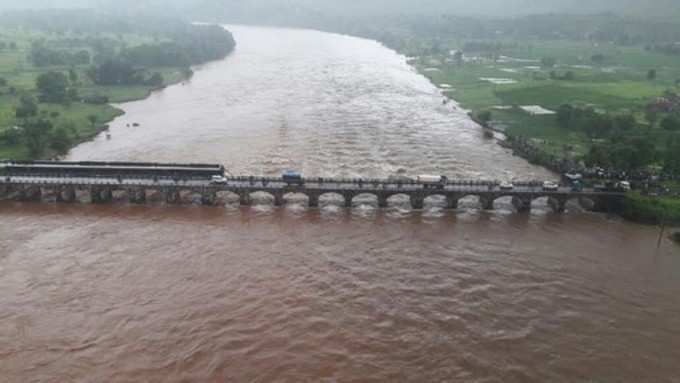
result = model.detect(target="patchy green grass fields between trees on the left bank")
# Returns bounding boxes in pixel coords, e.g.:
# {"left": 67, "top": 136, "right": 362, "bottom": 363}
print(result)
{"left": 0, "top": 28, "right": 186, "bottom": 159}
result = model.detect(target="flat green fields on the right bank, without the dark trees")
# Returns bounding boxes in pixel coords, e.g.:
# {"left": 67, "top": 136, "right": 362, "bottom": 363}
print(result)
{"left": 418, "top": 40, "right": 680, "bottom": 161}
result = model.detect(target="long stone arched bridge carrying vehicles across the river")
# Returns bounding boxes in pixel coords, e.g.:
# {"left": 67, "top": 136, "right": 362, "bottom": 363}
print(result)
{"left": 0, "top": 175, "right": 624, "bottom": 212}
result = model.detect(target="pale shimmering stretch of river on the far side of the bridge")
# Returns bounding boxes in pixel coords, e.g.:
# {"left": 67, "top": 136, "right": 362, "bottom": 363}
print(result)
{"left": 69, "top": 27, "right": 550, "bottom": 179}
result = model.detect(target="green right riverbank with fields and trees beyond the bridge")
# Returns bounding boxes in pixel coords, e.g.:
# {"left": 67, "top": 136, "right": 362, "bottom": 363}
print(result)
{"left": 396, "top": 38, "right": 680, "bottom": 223}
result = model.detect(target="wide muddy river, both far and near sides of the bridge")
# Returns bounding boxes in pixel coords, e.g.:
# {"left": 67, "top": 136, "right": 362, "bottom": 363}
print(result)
{"left": 0, "top": 26, "right": 680, "bottom": 383}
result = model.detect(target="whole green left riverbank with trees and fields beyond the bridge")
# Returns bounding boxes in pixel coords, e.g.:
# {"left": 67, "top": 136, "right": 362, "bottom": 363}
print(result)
{"left": 0, "top": 10, "right": 235, "bottom": 159}
